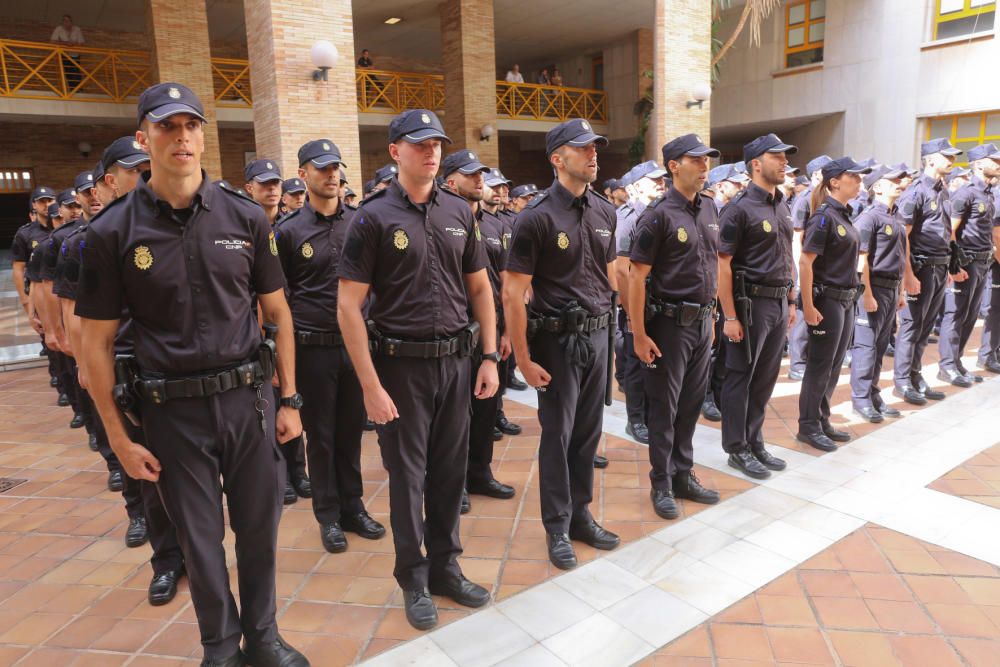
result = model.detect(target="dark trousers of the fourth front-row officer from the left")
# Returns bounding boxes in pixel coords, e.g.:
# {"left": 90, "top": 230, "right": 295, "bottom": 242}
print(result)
{"left": 642, "top": 317, "right": 713, "bottom": 491}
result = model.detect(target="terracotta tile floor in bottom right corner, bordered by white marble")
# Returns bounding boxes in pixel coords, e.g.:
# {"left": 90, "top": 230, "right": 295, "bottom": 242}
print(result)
{"left": 640, "top": 524, "right": 1000, "bottom": 667}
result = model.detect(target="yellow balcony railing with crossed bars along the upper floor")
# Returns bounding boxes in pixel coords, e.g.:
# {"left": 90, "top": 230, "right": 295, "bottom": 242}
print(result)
{"left": 0, "top": 39, "right": 608, "bottom": 122}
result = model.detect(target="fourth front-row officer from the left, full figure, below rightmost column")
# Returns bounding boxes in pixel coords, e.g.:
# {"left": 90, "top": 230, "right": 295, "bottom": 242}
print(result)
{"left": 619, "top": 134, "right": 719, "bottom": 519}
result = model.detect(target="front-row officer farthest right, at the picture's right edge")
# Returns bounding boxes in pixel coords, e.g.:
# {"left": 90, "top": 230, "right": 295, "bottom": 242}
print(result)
{"left": 938, "top": 144, "right": 1000, "bottom": 387}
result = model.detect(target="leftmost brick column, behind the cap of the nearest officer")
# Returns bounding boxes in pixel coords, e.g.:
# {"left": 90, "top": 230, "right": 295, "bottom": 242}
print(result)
{"left": 146, "top": 0, "right": 222, "bottom": 179}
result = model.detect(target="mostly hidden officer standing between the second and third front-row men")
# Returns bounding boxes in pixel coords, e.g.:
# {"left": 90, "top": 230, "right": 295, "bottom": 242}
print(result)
{"left": 441, "top": 150, "right": 521, "bottom": 499}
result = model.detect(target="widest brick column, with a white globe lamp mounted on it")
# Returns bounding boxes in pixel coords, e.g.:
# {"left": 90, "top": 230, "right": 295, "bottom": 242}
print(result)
{"left": 243, "top": 0, "right": 362, "bottom": 188}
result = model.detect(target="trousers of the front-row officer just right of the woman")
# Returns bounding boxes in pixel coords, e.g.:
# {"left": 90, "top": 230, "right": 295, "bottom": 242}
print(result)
{"left": 851, "top": 286, "right": 899, "bottom": 410}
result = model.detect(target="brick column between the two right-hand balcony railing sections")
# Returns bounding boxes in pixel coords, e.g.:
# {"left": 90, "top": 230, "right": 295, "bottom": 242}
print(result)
{"left": 440, "top": 0, "right": 500, "bottom": 167}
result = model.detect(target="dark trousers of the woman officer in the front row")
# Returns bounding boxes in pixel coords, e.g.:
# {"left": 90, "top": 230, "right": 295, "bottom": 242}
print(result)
{"left": 799, "top": 294, "right": 855, "bottom": 435}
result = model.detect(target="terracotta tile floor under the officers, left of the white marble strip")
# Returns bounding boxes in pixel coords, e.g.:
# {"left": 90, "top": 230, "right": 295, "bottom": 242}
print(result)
{"left": 0, "top": 368, "right": 751, "bottom": 667}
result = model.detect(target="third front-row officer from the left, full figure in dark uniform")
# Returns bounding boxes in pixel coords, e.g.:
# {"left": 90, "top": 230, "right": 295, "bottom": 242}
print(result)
{"left": 503, "top": 118, "right": 619, "bottom": 569}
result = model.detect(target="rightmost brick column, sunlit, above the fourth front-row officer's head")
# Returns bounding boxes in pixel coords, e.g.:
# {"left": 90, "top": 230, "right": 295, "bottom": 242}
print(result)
{"left": 646, "top": 0, "right": 712, "bottom": 161}
